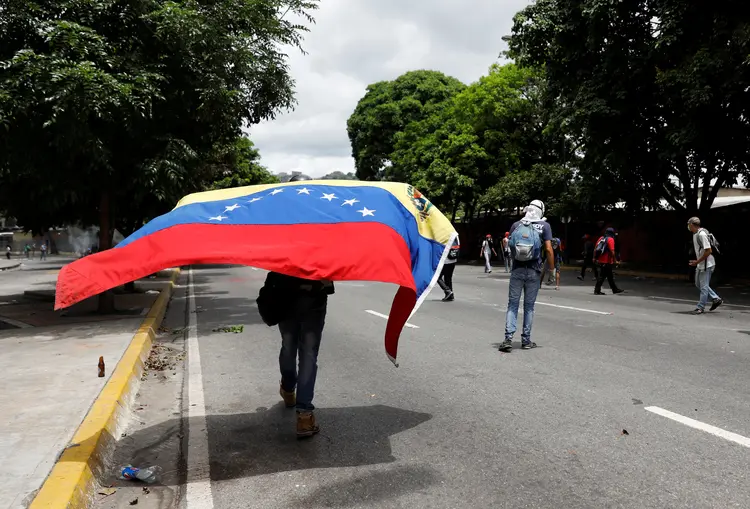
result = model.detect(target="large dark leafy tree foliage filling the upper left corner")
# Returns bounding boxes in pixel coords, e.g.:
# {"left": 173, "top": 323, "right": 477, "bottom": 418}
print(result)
{"left": 0, "top": 0, "right": 317, "bottom": 234}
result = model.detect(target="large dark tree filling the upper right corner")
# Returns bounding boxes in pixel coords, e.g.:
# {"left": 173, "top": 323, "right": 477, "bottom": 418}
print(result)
{"left": 510, "top": 0, "right": 750, "bottom": 212}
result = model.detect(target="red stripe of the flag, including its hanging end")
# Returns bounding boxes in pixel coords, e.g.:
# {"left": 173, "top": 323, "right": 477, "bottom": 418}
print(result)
{"left": 55, "top": 222, "right": 416, "bottom": 360}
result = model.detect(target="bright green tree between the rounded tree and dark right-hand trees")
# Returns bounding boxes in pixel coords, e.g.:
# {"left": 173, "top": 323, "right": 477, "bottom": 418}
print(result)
{"left": 385, "top": 64, "right": 574, "bottom": 217}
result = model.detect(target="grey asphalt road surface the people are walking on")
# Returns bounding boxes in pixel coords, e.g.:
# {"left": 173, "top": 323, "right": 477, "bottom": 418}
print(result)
{"left": 117, "top": 266, "right": 750, "bottom": 509}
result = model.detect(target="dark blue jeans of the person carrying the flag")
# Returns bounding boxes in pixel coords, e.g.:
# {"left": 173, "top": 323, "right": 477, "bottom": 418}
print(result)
{"left": 279, "top": 294, "right": 328, "bottom": 412}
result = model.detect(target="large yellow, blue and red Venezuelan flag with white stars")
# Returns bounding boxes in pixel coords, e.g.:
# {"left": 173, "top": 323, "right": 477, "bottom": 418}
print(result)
{"left": 55, "top": 180, "right": 456, "bottom": 364}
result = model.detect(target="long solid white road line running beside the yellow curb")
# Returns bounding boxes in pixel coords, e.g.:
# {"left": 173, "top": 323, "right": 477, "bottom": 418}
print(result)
{"left": 185, "top": 268, "right": 214, "bottom": 509}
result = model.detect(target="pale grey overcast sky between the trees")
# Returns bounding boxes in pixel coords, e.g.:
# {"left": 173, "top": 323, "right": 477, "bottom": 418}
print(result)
{"left": 250, "top": 0, "right": 529, "bottom": 177}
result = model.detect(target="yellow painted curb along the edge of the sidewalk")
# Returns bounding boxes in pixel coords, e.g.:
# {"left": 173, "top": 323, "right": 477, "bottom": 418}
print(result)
{"left": 29, "top": 269, "right": 180, "bottom": 509}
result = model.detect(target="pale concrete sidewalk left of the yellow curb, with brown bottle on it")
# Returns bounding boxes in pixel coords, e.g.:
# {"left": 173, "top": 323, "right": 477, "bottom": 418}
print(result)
{"left": 0, "top": 262, "right": 179, "bottom": 509}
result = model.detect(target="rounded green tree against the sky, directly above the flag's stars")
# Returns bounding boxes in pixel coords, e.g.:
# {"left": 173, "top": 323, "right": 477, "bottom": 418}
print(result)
{"left": 347, "top": 71, "right": 465, "bottom": 180}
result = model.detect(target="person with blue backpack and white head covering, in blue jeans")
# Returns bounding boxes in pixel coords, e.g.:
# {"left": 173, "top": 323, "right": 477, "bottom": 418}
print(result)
{"left": 499, "top": 200, "right": 555, "bottom": 352}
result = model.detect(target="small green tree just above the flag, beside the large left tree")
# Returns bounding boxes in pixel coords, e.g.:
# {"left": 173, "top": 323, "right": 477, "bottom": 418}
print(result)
{"left": 209, "top": 136, "right": 279, "bottom": 189}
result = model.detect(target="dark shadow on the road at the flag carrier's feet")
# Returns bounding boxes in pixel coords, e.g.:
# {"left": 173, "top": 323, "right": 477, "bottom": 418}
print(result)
{"left": 101, "top": 402, "right": 435, "bottom": 486}
